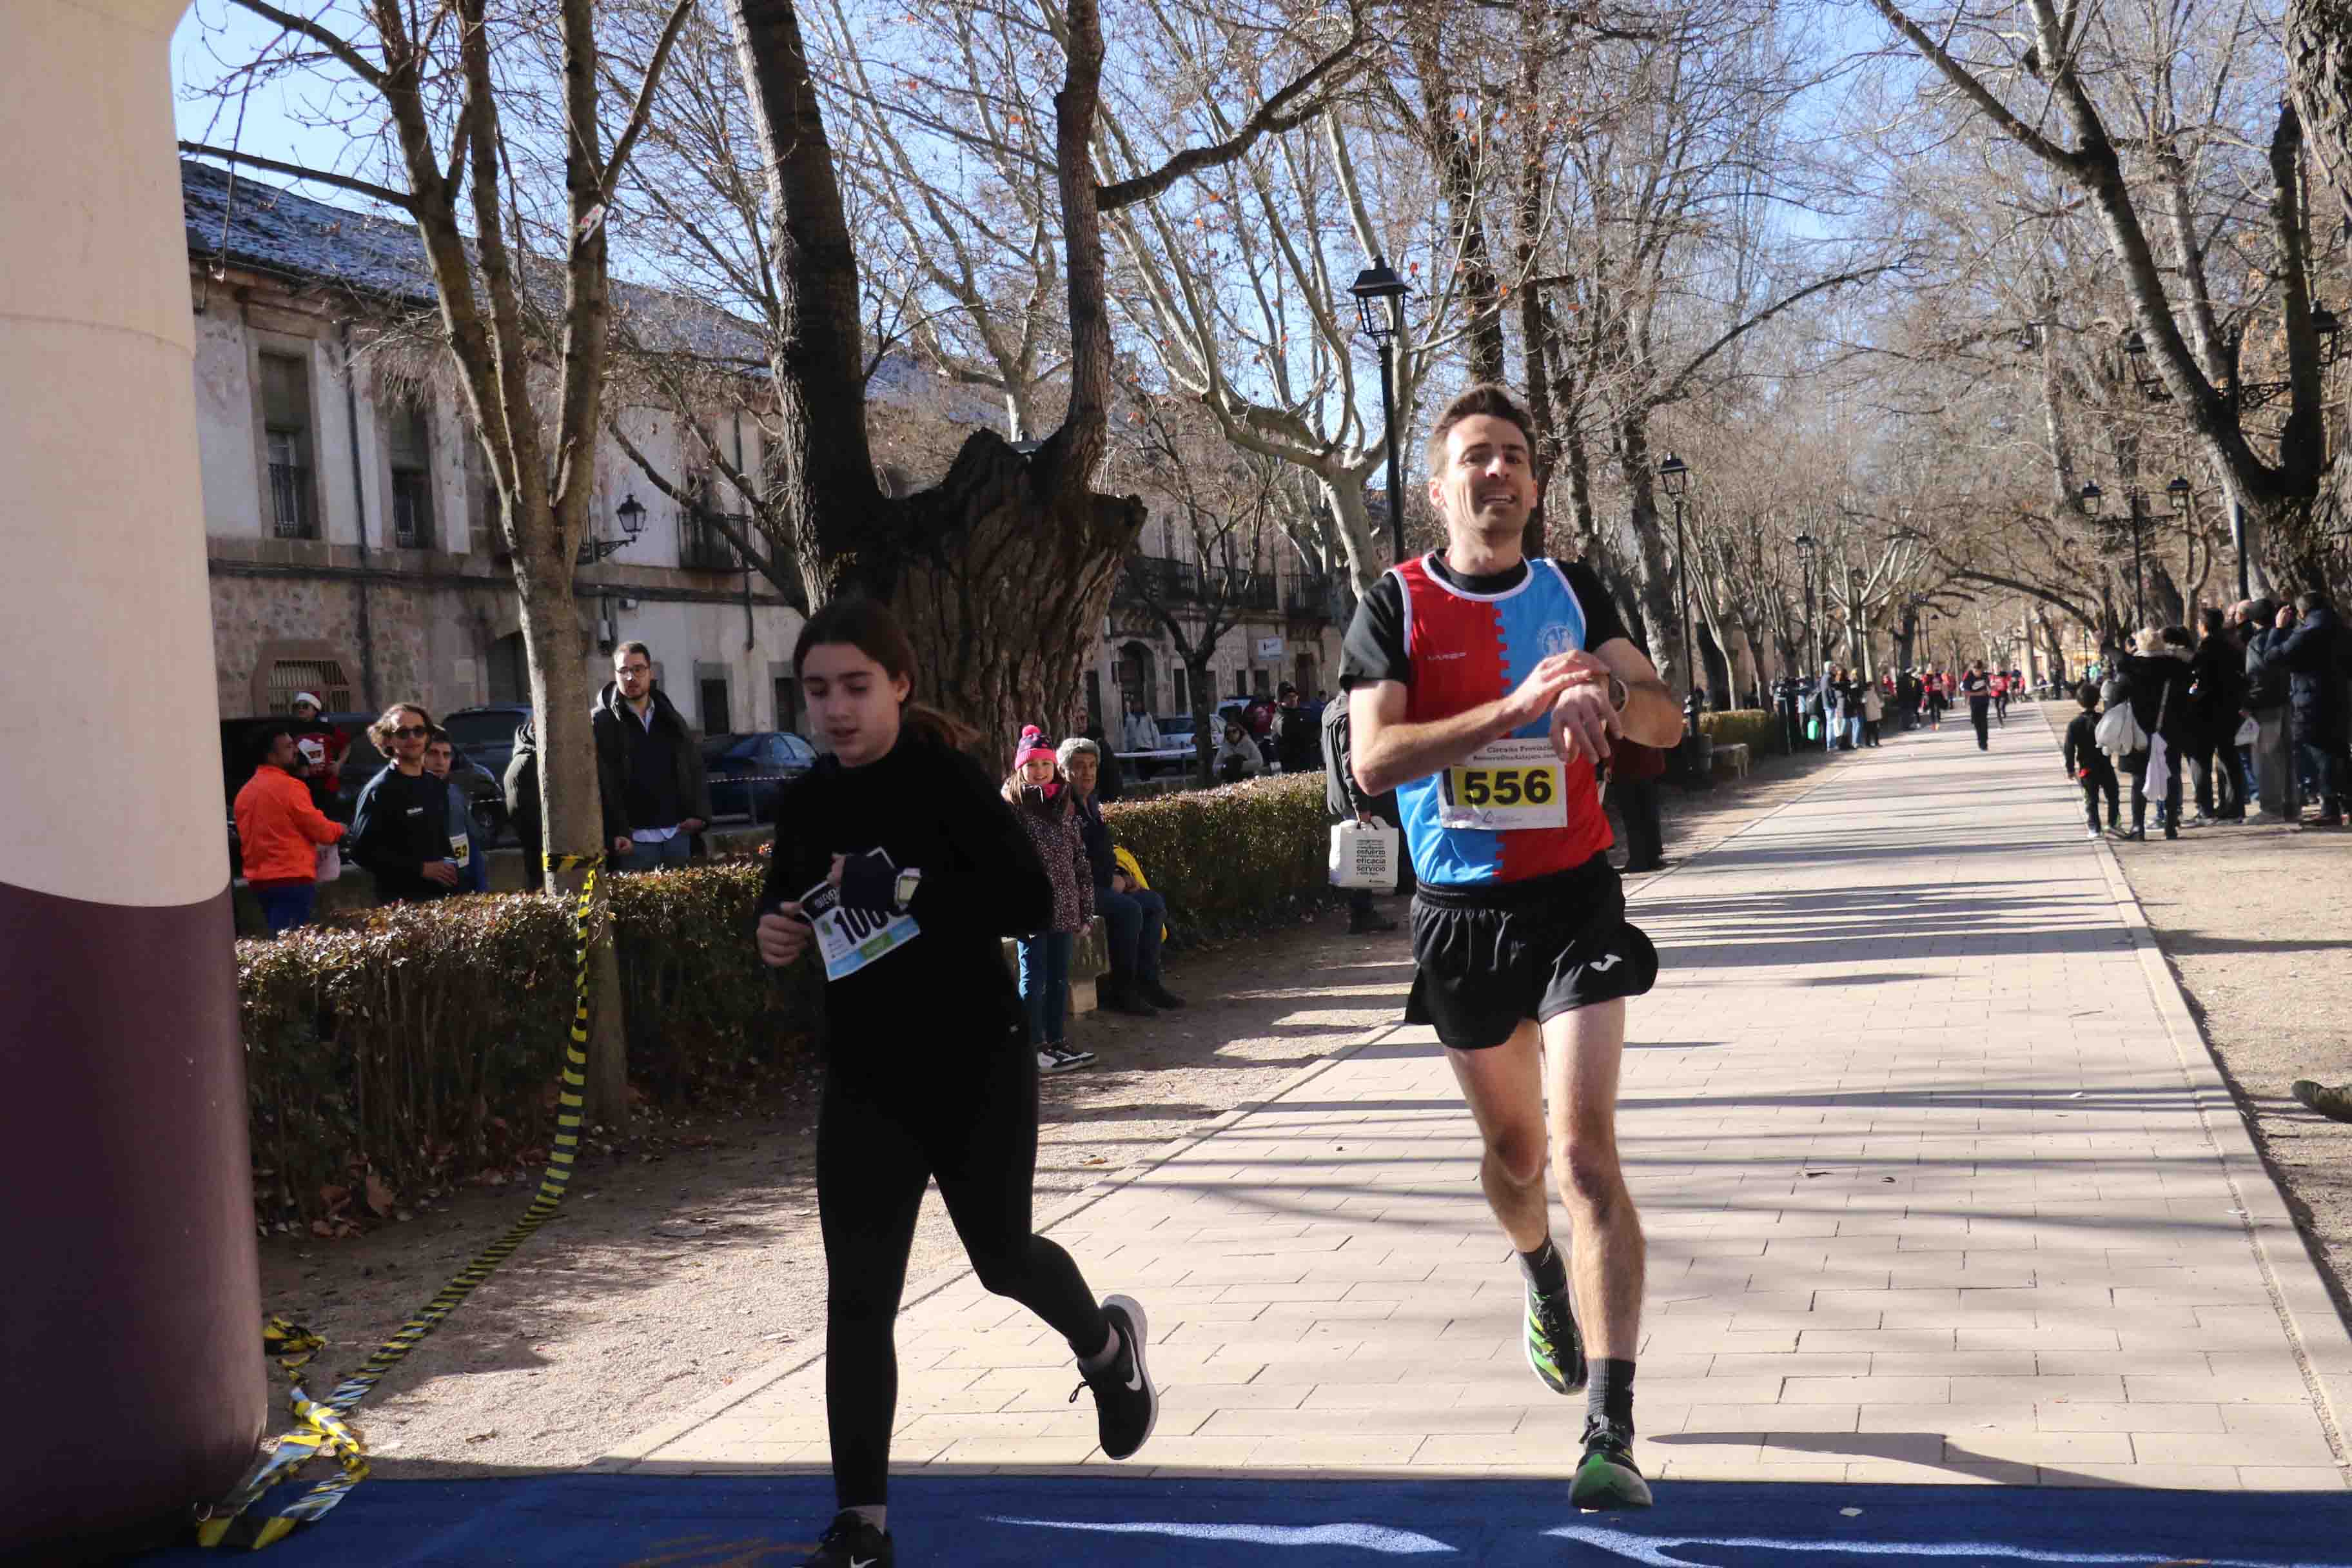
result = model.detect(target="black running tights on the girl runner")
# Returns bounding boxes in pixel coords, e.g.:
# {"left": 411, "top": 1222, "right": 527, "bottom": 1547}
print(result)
{"left": 816, "top": 1034, "right": 1110, "bottom": 1509}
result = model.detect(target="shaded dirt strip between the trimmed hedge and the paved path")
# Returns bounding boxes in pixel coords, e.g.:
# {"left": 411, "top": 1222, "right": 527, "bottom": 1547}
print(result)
{"left": 261, "top": 754, "right": 1834, "bottom": 1478}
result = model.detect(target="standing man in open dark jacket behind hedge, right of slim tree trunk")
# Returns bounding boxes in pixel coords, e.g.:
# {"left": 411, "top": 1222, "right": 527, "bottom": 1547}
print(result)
{"left": 591, "top": 642, "right": 710, "bottom": 872}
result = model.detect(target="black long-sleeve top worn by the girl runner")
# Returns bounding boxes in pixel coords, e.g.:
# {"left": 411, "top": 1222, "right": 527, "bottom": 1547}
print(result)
{"left": 760, "top": 734, "right": 1054, "bottom": 1058}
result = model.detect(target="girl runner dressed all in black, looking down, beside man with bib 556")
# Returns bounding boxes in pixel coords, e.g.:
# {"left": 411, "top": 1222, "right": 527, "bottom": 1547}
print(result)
{"left": 758, "top": 600, "right": 1159, "bottom": 1568}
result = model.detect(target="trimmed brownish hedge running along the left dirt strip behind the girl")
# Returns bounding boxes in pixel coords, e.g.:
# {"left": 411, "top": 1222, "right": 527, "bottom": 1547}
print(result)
{"left": 237, "top": 776, "right": 1331, "bottom": 1234}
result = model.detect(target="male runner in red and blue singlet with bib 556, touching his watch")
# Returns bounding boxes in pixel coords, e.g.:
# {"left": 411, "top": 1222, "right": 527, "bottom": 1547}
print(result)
{"left": 1340, "top": 386, "right": 1681, "bottom": 1509}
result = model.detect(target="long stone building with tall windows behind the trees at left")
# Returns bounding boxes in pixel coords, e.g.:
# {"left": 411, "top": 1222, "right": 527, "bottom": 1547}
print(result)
{"left": 181, "top": 160, "right": 1348, "bottom": 734}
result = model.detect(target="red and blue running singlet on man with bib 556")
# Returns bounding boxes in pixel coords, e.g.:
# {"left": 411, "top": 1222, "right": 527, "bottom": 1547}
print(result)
{"left": 1390, "top": 557, "right": 1614, "bottom": 887}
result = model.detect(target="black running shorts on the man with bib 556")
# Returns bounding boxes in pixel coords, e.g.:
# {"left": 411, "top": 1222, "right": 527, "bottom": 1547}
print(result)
{"left": 1404, "top": 856, "right": 1658, "bottom": 1051}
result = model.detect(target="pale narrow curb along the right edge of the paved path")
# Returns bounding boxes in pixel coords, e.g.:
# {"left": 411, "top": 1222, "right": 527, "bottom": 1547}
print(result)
{"left": 2041, "top": 705, "right": 2352, "bottom": 1467}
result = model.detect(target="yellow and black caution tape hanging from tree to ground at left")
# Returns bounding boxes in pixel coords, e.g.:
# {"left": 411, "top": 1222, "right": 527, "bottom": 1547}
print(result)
{"left": 195, "top": 856, "right": 605, "bottom": 1551}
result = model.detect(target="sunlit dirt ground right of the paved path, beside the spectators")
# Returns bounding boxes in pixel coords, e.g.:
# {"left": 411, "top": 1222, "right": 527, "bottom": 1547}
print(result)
{"left": 2053, "top": 710, "right": 2352, "bottom": 1321}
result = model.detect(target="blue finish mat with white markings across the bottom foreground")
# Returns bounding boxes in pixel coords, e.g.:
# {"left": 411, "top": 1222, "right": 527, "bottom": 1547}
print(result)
{"left": 144, "top": 1474, "right": 2352, "bottom": 1568}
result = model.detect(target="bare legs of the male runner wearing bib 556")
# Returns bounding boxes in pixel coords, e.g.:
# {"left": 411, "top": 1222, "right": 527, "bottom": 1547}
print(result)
{"left": 1447, "top": 999, "right": 1647, "bottom": 1361}
